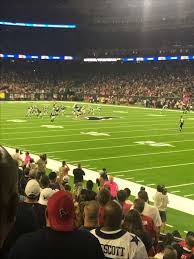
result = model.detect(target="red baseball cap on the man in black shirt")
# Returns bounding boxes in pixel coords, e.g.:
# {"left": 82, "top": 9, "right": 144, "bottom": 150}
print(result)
{"left": 47, "top": 191, "right": 74, "bottom": 232}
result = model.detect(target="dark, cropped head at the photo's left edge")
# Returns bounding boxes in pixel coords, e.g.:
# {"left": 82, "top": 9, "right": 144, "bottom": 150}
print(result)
{"left": 0, "top": 146, "right": 18, "bottom": 247}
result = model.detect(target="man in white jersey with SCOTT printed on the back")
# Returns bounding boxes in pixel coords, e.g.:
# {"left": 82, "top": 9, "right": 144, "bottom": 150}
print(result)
{"left": 91, "top": 201, "right": 148, "bottom": 259}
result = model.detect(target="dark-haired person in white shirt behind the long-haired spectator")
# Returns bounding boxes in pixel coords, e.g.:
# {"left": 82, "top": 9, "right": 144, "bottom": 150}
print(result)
{"left": 138, "top": 191, "right": 162, "bottom": 242}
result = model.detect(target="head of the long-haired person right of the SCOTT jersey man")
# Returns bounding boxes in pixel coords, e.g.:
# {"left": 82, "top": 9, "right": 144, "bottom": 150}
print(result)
{"left": 123, "top": 210, "right": 143, "bottom": 235}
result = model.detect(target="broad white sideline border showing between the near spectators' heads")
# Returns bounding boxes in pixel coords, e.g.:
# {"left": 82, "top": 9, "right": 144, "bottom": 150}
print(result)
{"left": 3, "top": 147, "right": 194, "bottom": 215}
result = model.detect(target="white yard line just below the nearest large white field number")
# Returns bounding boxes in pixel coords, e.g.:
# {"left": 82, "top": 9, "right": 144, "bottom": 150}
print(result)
{"left": 69, "top": 149, "right": 194, "bottom": 163}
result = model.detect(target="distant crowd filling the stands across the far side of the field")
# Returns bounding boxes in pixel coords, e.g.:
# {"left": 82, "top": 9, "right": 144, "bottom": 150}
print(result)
{"left": 0, "top": 62, "right": 194, "bottom": 109}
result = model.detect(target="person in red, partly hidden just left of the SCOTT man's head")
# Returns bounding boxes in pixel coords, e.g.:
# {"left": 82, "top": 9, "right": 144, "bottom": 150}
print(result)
{"left": 97, "top": 188, "right": 111, "bottom": 226}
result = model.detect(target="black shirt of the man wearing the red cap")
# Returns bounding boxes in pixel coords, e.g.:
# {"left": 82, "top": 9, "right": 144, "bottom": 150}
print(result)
{"left": 9, "top": 228, "right": 104, "bottom": 259}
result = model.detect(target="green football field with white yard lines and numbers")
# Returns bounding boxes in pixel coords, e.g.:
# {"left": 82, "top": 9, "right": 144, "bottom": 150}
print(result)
{"left": 0, "top": 102, "right": 194, "bottom": 236}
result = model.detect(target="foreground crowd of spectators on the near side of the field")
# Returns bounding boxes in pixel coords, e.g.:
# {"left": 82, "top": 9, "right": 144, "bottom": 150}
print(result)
{"left": 0, "top": 147, "right": 194, "bottom": 259}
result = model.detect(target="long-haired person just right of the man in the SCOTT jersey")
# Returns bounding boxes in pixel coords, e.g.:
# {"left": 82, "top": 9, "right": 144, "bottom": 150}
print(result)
{"left": 123, "top": 210, "right": 154, "bottom": 256}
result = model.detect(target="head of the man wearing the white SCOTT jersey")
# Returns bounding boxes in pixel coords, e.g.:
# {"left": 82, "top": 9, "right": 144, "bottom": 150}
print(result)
{"left": 104, "top": 201, "right": 123, "bottom": 229}
